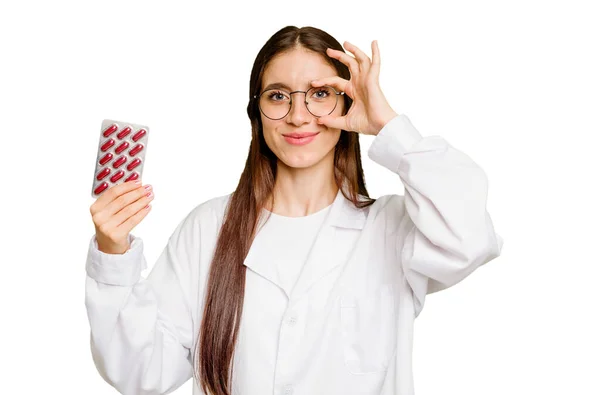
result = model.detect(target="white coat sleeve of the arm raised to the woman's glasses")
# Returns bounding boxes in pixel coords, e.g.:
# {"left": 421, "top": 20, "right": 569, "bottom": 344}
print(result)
{"left": 368, "top": 114, "right": 503, "bottom": 316}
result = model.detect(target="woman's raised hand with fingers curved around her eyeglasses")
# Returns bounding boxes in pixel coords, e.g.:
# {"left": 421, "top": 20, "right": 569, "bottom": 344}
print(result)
{"left": 312, "top": 40, "right": 398, "bottom": 135}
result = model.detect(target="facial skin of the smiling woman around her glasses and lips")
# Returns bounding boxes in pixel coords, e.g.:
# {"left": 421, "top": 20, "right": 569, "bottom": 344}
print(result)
{"left": 260, "top": 49, "right": 344, "bottom": 168}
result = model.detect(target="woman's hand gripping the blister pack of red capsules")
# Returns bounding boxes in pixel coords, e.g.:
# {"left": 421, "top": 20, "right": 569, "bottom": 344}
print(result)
{"left": 90, "top": 181, "right": 154, "bottom": 254}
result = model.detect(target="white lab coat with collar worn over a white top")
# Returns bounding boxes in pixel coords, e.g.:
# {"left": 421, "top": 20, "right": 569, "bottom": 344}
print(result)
{"left": 85, "top": 114, "right": 503, "bottom": 395}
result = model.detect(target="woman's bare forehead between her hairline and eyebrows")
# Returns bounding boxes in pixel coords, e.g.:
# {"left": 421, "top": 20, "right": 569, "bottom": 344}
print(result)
{"left": 261, "top": 49, "right": 337, "bottom": 89}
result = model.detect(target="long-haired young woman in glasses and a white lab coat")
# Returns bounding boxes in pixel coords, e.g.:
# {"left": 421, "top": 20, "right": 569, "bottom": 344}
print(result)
{"left": 86, "top": 26, "right": 503, "bottom": 395}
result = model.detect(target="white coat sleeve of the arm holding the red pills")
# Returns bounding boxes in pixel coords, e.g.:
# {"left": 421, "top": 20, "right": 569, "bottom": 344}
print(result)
{"left": 85, "top": 216, "right": 197, "bottom": 395}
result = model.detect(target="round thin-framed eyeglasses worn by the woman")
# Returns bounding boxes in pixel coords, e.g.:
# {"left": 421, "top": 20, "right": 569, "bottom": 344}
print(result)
{"left": 254, "top": 85, "right": 344, "bottom": 120}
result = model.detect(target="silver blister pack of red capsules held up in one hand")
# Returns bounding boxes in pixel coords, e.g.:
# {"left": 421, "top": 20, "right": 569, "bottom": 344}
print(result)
{"left": 92, "top": 119, "right": 150, "bottom": 198}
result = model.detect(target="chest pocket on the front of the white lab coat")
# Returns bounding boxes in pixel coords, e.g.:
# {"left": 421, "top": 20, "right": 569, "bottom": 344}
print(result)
{"left": 340, "top": 285, "right": 396, "bottom": 374}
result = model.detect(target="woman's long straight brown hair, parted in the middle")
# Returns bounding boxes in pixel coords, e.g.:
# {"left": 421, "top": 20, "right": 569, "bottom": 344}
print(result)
{"left": 194, "top": 26, "right": 375, "bottom": 395}
